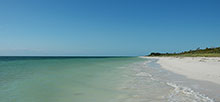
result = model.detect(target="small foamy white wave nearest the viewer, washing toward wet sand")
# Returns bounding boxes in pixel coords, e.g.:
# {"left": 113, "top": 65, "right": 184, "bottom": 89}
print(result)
{"left": 167, "top": 82, "right": 214, "bottom": 102}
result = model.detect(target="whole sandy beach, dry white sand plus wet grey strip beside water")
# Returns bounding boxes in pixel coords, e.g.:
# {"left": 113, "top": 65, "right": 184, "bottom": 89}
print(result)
{"left": 147, "top": 57, "right": 220, "bottom": 102}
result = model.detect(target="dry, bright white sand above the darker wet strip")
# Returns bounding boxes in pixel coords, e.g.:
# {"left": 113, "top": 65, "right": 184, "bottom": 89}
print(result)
{"left": 148, "top": 57, "right": 220, "bottom": 85}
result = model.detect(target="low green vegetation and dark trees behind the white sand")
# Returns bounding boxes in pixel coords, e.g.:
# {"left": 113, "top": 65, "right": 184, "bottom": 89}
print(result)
{"left": 148, "top": 47, "right": 220, "bottom": 57}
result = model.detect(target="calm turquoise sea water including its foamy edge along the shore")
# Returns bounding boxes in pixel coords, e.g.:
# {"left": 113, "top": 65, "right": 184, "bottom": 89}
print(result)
{"left": 0, "top": 57, "right": 215, "bottom": 102}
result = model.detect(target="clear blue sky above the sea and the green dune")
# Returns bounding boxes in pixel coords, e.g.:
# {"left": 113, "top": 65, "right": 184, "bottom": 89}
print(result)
{"left": 0, "top": 0, "right": 220, "bottom": 56}
